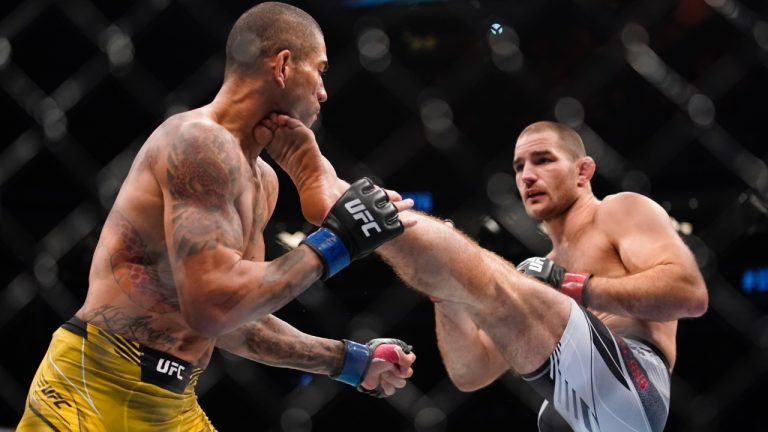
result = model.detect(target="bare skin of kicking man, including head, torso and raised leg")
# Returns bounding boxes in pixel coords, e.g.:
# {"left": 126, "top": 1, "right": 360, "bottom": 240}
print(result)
{"left": 377, "top": 127, "right": 707, "bottom": 391}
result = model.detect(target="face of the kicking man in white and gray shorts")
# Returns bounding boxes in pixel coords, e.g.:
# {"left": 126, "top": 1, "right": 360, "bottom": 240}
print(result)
{"left": 513, "top": 131, "right": 577, "bottom": 221}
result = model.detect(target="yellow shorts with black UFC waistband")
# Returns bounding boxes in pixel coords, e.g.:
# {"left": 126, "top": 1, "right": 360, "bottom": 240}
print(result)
{"left": 17, "top": 318, "right": 215, "bottom": 432}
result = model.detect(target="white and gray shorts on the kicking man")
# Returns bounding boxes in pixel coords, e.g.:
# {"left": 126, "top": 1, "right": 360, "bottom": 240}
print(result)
{"left": 523, "top": 300, "right": 670, "bottom": 432}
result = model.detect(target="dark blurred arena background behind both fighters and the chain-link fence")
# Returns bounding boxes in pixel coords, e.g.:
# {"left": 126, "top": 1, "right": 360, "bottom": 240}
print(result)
{"left": 0, "top": 0, "right": 768, "bottom": 432}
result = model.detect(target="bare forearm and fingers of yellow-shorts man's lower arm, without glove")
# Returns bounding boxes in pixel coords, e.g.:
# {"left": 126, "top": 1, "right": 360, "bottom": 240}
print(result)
{"left": 216, "top": 315, "right": 416, "bottom": 395}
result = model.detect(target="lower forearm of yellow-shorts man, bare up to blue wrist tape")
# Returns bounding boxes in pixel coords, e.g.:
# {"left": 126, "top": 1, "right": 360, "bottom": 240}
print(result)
{"left": 216, "top": 315, "right": 344, "bottom": 375}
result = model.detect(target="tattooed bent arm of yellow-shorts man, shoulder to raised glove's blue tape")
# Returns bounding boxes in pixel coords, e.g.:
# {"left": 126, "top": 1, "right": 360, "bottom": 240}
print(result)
{"left": 162, "top": 122, "right": 323, "bottom": 337}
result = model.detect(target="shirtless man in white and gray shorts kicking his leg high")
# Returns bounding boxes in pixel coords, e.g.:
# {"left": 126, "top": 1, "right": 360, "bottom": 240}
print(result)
{"left": 378, "top": 122, "right": 707, "bottom": 432}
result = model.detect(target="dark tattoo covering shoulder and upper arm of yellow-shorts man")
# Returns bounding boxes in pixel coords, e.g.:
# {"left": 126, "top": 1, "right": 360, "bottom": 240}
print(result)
{"left": 166, "top": 127, "right": 243, "bottom": 260}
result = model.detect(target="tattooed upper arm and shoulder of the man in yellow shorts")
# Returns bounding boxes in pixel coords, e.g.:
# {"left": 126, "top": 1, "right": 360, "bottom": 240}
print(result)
{"left": 156, "top": 122, "right": 250, "bottom": 303}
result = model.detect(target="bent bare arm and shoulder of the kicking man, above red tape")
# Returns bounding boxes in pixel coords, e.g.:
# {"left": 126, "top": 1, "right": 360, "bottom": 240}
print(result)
{"left": 588, "top": 193, "right": 708, "bottom": 321}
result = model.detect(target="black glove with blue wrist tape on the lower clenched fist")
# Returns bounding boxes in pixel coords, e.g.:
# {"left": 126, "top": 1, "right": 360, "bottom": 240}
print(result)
{"left": 331, "top": 338, "right": 413, "bottom": 398}
